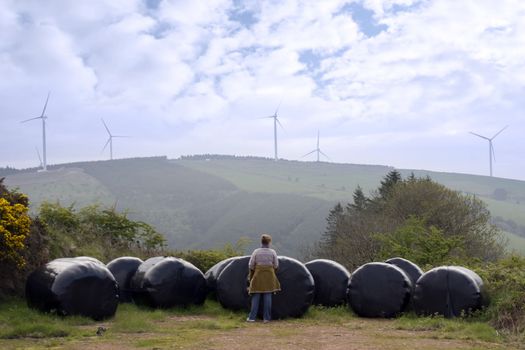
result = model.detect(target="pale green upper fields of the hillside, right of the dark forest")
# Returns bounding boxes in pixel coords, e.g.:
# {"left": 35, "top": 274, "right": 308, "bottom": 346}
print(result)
{"left": 176, "top": 157, "right": 525, "bottom": 225}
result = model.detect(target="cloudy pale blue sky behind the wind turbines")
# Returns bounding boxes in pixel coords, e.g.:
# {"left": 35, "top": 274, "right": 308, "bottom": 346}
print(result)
{"left": 0, "top": 0, "right": 525, "bottom": 180}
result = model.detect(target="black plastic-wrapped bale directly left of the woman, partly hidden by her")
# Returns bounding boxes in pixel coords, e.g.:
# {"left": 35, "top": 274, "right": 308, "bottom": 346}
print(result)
{"left": 217, "top": 256, "right": 250, "bottom": 310}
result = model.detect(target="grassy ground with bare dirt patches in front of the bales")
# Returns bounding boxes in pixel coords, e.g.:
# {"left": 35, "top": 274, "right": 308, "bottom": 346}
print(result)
{"left": 0, "top": 299, "right": 519, "bottom": 349}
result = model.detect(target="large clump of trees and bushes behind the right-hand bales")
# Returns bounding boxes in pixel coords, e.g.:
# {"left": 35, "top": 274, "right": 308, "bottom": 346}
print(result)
{"left": 310, "top": 170, "right": 506, "bottom": 269}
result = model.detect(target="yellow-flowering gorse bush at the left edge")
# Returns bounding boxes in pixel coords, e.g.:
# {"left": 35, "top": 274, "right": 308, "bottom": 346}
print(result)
{"left": 0, "top": 198, "right": 31, "bottom": 268}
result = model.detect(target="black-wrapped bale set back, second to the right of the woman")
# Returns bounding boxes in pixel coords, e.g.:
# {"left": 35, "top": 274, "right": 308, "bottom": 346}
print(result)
{"left": 304, "top": 259, "right": 350, "bottom": 307}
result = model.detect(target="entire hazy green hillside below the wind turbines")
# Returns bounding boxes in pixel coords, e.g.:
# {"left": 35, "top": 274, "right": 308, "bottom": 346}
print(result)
{"left": 4, "top": 156, "right": 525, "bottom": 255}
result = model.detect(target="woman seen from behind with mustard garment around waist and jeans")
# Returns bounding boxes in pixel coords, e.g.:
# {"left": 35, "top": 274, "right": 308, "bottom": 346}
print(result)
{"left": 246, "top": 234, "right": 281, "bottom": 322}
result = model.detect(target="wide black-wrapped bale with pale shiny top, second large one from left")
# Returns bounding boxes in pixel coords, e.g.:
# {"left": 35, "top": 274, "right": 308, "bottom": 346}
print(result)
{"left": 131, "top": 257, "right": 206, "bottom": 308}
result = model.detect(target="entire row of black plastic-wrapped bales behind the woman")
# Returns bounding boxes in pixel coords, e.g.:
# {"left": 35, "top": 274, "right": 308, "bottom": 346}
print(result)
{"left": 26, "top": 256, "right": 486, "bottom": 320}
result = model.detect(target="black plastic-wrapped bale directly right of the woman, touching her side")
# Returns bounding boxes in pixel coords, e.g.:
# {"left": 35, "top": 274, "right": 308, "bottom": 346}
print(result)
{"left": 270, "top": 256, "right": 315, "bottom": 319}
